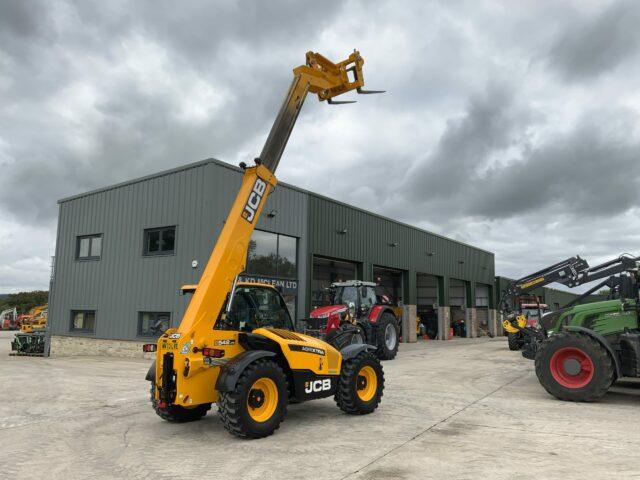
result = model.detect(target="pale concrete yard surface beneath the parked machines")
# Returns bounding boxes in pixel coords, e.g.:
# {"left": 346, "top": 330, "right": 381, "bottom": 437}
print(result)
{"left": 0, "top": 332, "right": 640, "bottom": 480}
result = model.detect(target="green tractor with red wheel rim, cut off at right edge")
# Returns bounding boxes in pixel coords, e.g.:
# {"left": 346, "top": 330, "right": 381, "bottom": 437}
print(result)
{"left": 502, "top": 256, "right": 640, "bottom": 402}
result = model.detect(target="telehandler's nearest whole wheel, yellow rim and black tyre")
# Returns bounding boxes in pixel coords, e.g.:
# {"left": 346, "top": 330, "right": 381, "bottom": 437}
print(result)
{"left": 218, "top": 359, "right": 288, "bottom": 438}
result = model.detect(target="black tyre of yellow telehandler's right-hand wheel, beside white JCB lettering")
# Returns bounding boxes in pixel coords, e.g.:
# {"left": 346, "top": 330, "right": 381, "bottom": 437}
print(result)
{"left": 334, "top": 351, "right": 384, "bottom": 415}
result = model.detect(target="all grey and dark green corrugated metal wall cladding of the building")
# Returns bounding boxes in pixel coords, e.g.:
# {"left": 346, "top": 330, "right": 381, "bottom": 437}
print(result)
{"left": 50, "top": 156, "right": 494, "bottom": 339}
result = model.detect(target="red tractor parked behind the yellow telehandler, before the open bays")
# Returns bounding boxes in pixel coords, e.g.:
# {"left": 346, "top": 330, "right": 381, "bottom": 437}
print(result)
{"left": 306, "top": 280, "right": 402, "bottom": 360}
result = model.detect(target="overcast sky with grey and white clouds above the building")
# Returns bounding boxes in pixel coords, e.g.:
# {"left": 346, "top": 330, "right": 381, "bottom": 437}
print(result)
{"left": 0, "top": 0, "right": 640, "bottom": 293}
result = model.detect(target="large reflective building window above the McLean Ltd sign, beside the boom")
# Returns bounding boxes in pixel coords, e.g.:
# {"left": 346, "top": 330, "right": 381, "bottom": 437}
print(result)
{"left": 245, "top": 230, "right": 297, "bottom": 279}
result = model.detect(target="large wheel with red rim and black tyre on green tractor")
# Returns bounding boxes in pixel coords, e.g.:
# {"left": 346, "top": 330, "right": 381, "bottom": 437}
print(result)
{"left": 535, "top": 332, "right": 615, "bottom": 402}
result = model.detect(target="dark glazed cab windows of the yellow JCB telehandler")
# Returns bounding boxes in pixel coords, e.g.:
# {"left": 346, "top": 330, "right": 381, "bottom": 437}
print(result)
{"left": 216, "top": 286, "right": 293, "bottom": 332}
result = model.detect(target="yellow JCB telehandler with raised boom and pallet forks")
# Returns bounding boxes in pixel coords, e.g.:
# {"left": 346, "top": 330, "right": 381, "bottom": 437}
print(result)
{"left": 143, "top": 51, "right": 384, "bottom": 438}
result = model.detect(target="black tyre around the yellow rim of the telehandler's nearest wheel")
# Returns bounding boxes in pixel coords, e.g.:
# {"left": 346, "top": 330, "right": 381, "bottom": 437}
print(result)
{"left": 218, "top": 359, "right": 288, "bottom": 438}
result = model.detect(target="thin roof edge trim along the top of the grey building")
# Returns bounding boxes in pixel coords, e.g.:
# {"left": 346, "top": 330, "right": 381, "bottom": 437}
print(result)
{"left": 58, "top": 158, "right": 493, "bottom": 255}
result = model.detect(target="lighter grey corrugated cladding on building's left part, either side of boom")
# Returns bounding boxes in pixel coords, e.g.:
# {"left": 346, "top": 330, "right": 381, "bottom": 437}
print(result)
{"left": 49, "top": 161, "right": 307, "bottom": 339}
